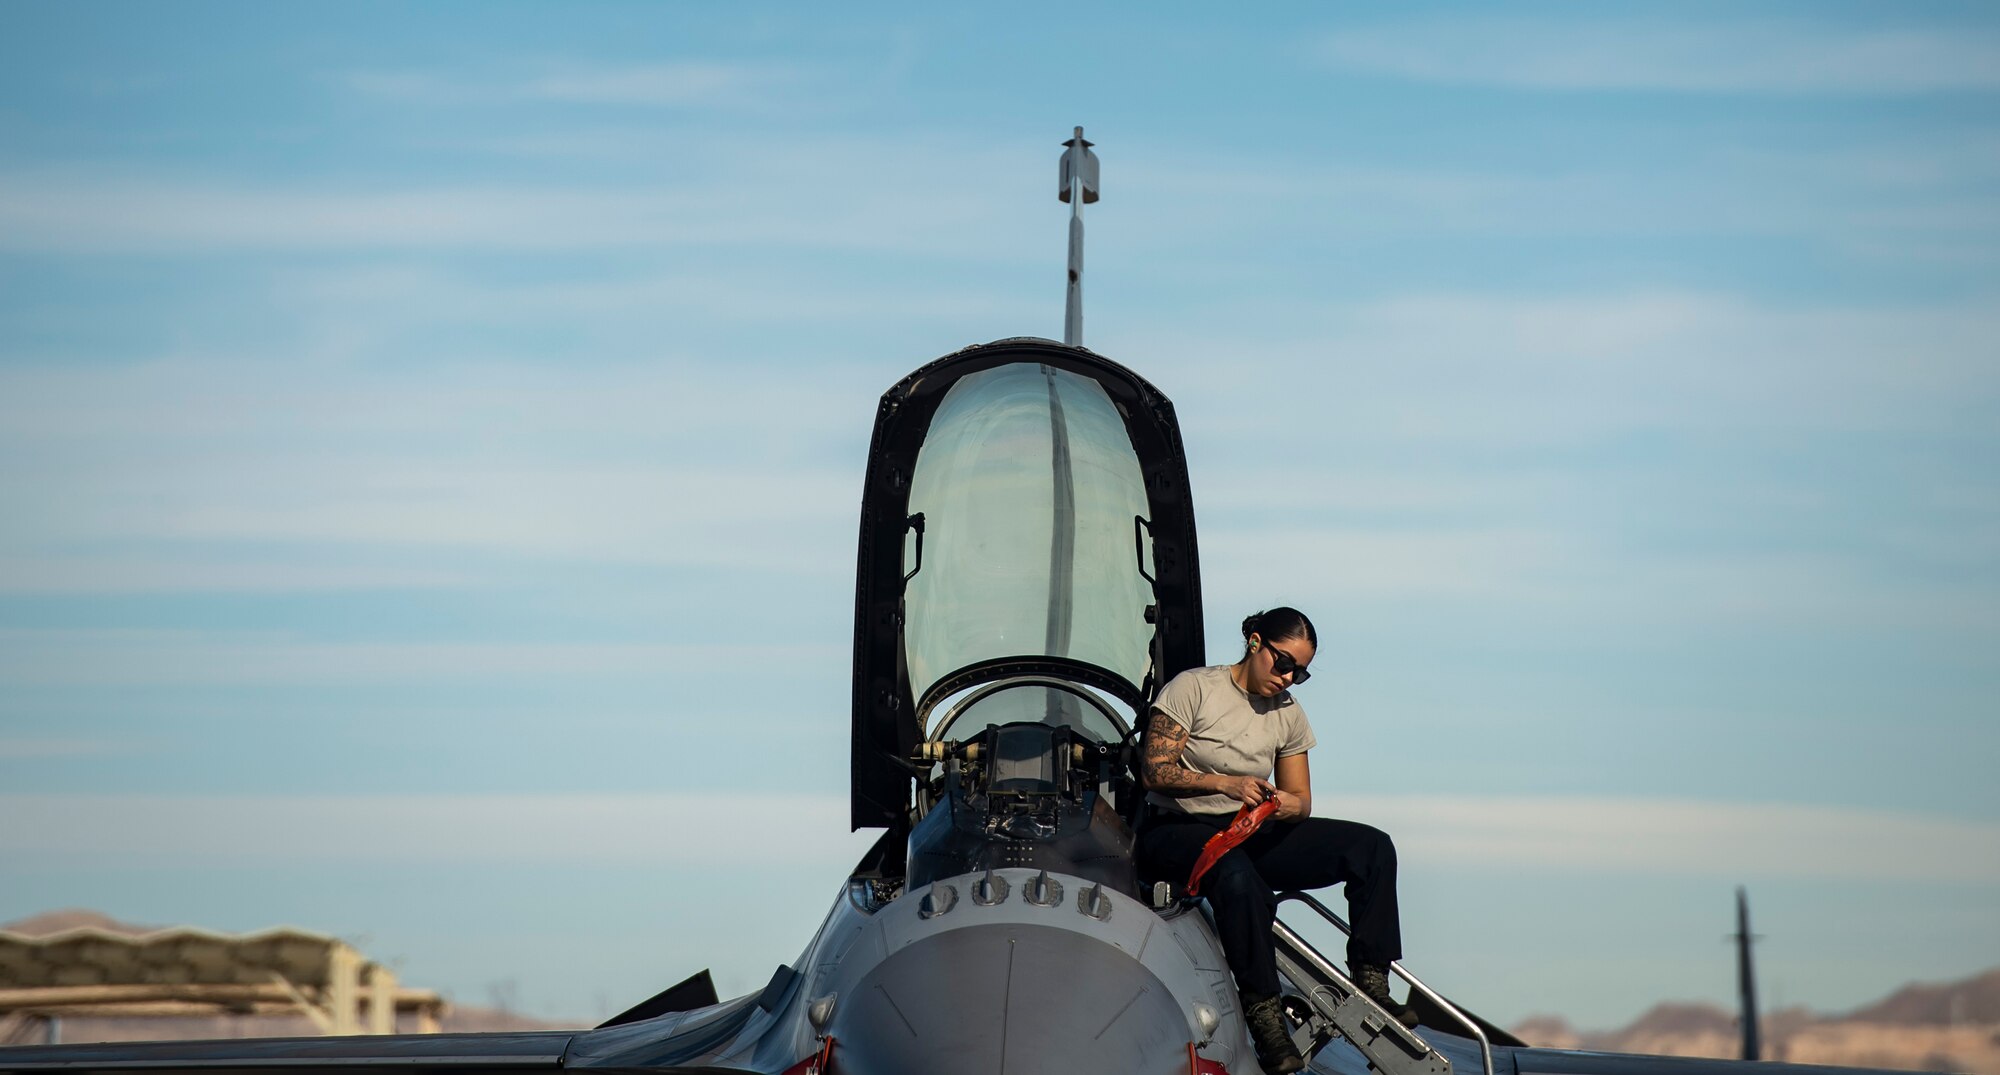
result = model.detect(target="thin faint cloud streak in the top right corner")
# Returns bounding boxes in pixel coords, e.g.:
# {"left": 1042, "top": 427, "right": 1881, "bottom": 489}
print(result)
{"left": 1318, "top": 17, "right": 2000, "bottom": 96}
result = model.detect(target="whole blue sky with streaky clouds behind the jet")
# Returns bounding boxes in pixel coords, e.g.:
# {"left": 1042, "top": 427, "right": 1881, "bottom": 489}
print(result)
{"left": 0, "top": 2, "right": 2000, "bottom": 1025}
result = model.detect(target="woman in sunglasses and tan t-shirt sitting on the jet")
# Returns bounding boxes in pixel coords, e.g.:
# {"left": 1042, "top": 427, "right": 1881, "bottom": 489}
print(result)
{"left": 1138, "top": 607, "right": 1414, "bottom": 1073}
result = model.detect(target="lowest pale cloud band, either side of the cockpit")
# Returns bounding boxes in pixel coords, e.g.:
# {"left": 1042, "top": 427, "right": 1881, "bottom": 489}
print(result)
{"left": 0, "top": 793, "right": 2000, "bottom": 883}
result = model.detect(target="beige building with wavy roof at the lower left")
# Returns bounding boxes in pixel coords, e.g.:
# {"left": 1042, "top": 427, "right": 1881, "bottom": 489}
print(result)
{"left": 0, "top": 911, "right": 446, "bottom": 1045}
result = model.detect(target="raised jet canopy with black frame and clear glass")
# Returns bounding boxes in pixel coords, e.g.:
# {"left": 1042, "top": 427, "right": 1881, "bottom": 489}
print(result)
{"left": 852, "top": 340, "right": 1202, "bottom": 827}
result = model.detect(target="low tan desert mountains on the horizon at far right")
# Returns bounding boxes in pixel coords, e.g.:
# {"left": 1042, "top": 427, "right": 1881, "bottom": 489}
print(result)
{"left": 1512, "top": 967, "right": 2000, "bottom": 1075}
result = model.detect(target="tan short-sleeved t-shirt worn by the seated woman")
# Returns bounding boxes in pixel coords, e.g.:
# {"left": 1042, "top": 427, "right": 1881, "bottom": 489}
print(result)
{"left": 1146, "top": 665, "right": 1318, "bottom": 813}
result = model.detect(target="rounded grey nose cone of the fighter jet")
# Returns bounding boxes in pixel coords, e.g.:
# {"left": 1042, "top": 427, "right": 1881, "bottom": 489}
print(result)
{"left": 828, "top": 923, "right": 1192, "bottom": 1075}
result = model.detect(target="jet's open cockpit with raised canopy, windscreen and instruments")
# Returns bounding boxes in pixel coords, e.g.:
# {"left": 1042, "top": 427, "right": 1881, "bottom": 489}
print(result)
{"left": 852, "top": 340, "right": 1202, "bottom": 891}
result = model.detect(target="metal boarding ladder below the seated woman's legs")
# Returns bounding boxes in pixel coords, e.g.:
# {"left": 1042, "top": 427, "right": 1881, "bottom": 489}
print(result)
{"left": 1272, "top": 891, "right": 1494, "bottom": 1075}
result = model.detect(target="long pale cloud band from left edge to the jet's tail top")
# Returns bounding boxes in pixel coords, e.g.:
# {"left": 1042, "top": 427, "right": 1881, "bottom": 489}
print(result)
{"left": 0, "top": 146, "right": 1046, "bottom": 258}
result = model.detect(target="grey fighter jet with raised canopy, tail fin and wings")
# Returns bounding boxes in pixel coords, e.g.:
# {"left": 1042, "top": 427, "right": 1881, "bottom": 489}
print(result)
{"left": 0, "top": 128, "right": 1928, "bottom": 1075}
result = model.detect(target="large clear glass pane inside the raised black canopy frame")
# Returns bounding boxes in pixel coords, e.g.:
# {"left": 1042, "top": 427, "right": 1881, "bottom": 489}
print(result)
{"left": 904, "top": 362, "right": 1152, "bottom": 699}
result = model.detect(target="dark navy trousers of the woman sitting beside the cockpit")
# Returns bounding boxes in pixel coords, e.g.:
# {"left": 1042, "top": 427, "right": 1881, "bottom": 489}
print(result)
{"left": 1138, "top": 809, "right": 1402, "bottom": 997}
